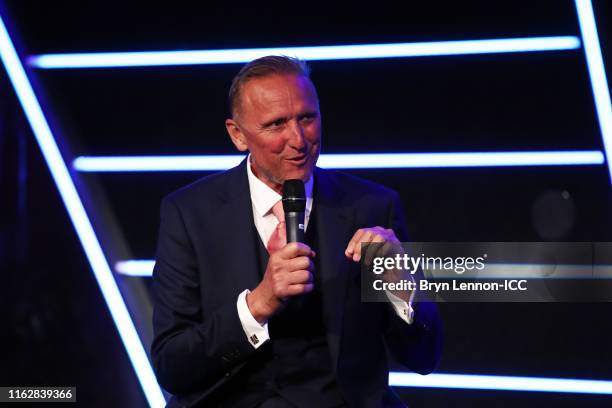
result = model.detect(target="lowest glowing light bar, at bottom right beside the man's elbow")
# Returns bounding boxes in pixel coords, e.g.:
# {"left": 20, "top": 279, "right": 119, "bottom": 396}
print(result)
{"left": 389, "top": 372, "right": 612, "bottom": 395}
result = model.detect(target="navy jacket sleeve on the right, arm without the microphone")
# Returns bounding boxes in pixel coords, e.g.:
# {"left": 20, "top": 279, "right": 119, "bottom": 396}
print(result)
{"left": 384, "top": 193, "right": 444, "bottom": 374}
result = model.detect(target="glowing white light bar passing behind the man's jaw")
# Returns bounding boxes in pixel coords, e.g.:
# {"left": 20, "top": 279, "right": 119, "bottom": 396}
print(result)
{"left": 73, "top": 150, "right": 604, "bottom": 172}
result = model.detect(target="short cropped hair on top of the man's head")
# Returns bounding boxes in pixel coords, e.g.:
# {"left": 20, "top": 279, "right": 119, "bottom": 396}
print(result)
{"left": 228, "top": 55, "right": 310, "bottom": 117}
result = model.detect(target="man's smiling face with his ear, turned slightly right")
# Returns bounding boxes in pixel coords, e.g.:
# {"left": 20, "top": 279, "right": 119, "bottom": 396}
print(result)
{"left": 226, "top": 74, "right": 321, "bottom": 191}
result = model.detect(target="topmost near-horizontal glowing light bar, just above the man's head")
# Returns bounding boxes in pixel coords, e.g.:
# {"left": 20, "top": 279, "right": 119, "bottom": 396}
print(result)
{"left": 28, "top": 36, "right": 580, "bottom": 69}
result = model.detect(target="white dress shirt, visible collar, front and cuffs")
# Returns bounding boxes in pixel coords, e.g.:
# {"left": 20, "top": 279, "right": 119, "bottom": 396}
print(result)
{"left": 236, "top": 155, "right": 414, "bottom": 348}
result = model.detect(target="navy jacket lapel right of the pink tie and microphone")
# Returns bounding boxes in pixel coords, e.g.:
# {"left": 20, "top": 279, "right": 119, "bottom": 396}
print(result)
{"left": 314, "top": 168, "right": 354, "bottom": 370}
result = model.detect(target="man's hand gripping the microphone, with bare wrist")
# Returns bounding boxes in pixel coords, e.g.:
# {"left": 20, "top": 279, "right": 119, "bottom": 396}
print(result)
{"left": 246, "top": 242, "right": 316, "bottom": 324}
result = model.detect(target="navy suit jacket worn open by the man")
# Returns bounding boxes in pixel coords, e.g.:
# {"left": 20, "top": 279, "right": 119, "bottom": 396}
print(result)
{"left": 151, "top": 160, "right": 442, "bottom": 407}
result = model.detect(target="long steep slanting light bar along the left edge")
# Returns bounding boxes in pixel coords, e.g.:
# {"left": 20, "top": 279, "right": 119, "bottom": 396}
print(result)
{"left": 0, "top": 16, "right": 166, "bottom": 407}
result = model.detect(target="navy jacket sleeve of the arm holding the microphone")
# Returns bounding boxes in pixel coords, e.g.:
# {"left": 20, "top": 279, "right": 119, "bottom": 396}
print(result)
{"left": 151, "top": 198, "right": 254, "bottom": 394}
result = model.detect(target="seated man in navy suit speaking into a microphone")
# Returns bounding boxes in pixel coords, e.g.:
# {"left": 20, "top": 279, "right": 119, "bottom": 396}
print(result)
{"left": 151, "top": 56, "right": 442, "bottom": 407}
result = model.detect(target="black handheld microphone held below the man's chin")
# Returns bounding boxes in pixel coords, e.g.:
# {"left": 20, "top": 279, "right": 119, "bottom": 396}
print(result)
{"left": 283, "top": 179, "right": 306, "bottom": 243}
